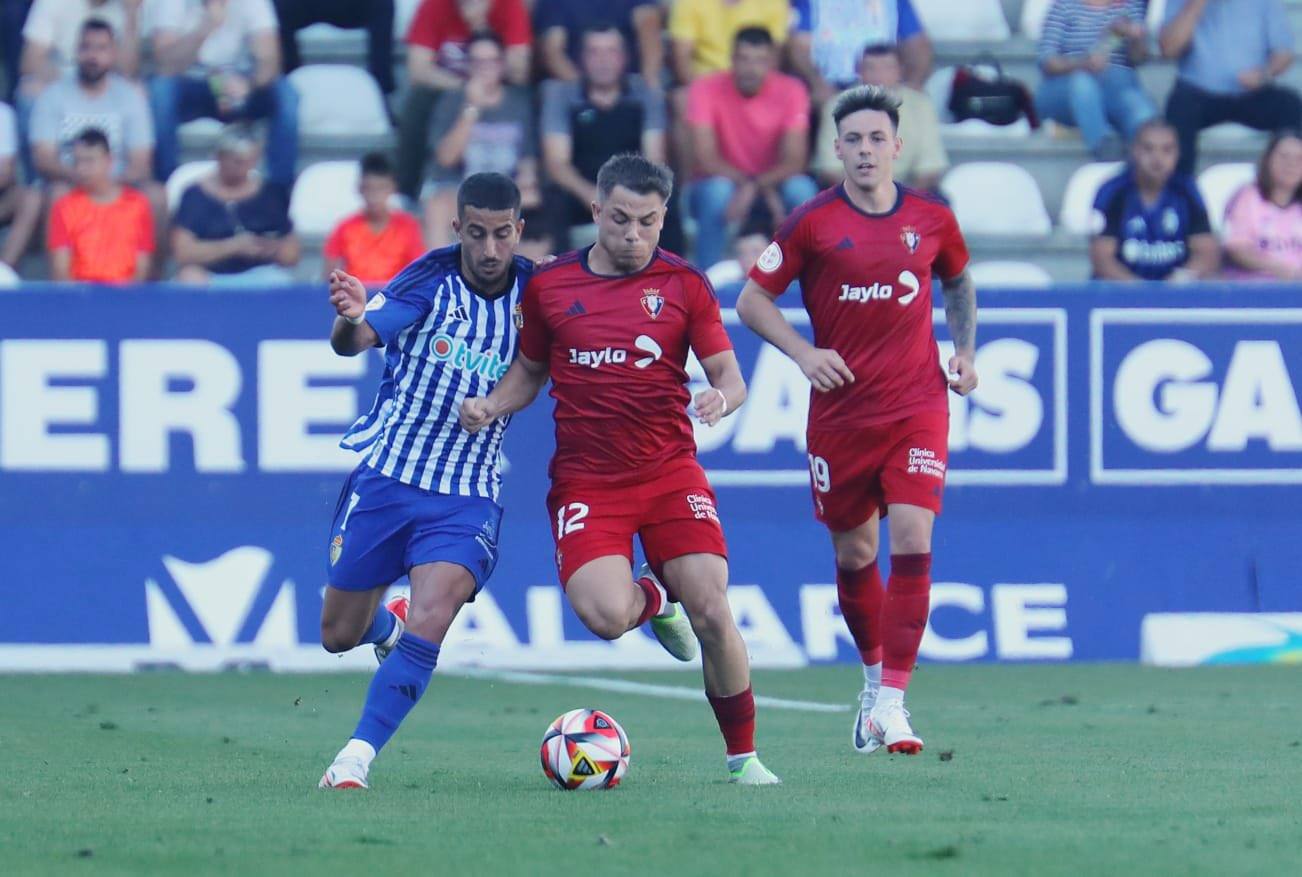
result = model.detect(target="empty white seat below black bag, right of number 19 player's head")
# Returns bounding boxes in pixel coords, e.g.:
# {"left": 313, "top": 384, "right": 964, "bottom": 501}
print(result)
{"left": 940, "top": 161, "right": 1052, "bottom": 237}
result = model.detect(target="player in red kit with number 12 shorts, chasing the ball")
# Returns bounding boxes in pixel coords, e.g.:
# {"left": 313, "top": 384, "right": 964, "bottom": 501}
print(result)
{"left": 461, "top": 155, "right": 779, "bottom": 785}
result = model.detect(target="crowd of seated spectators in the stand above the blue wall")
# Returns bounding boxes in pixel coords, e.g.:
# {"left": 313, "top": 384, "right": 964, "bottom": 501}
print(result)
{"left": 0, "top": 0, "right": 1302, "bottom": 286}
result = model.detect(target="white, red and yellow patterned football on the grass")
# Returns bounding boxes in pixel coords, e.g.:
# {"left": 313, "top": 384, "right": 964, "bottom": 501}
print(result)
{"left": 540, "top": 709, "right": 630, "bottom": 790}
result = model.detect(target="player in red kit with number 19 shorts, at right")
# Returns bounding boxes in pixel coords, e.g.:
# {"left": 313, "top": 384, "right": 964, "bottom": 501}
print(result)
{"left": 737, "top": 86, "right": 977, "bottom": 755}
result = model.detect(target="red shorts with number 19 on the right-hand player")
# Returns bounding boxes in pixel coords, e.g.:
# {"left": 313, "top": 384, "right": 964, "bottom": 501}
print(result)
{"left": 806, "top": 411, "right": 949, "bottom": 532}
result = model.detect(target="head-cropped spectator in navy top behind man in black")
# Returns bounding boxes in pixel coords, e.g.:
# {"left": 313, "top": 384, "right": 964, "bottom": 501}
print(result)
{"left": 534, "top": 0, "right": 664, "bottom": 88}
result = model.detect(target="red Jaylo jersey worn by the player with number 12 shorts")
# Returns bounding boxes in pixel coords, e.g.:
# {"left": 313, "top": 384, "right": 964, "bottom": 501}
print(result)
{"left": 519, "top": 249, "right": 732, "bottom": 481}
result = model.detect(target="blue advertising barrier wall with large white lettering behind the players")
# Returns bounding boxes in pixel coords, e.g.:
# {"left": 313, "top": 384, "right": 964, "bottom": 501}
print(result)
{"left": 0, "top": 286, "right": 1302, "bottom": 669}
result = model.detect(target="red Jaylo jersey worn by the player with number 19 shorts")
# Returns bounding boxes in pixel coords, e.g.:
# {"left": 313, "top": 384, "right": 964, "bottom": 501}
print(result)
{"left": 750, "top": 185, "right": 967, "bottom": 429}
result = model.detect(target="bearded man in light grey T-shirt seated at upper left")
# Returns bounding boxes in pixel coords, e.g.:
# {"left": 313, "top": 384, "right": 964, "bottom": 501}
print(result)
{"left": 30, "top": 18, "right": 159, "bottom": 187}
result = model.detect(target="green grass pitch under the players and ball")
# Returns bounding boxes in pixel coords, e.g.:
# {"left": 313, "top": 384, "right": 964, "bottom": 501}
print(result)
{"left": 0, "top": 665, "right": 1302, "bottom": 877}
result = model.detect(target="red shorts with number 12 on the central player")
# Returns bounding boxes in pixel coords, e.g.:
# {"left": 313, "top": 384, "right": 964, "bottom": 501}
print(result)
{"left": 547, "top": 459, "right": 728, "bottom": 587}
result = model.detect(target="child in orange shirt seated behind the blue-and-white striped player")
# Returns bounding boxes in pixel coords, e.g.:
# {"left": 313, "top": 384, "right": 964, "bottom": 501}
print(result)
{"left": 324, "top": 152, "right": 424, "bottom": 286}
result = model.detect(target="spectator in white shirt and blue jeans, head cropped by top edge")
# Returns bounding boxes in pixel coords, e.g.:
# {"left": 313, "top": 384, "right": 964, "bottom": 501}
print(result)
{"left": 146, "top": 0, "right": 298, "bottom": 189}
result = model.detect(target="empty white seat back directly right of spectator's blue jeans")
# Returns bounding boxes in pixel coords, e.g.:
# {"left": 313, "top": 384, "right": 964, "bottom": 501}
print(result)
{"left": 289, "top": 64, "right": 389, "bottom": 137}
